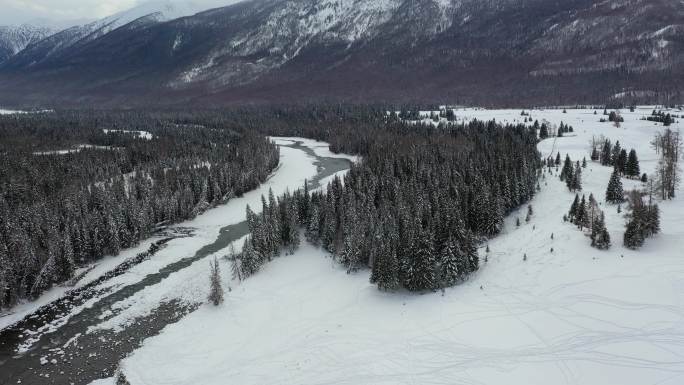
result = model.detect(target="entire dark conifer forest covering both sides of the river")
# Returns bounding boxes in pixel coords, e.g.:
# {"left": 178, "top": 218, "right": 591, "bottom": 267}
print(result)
{"left": 0, "top": 105, "right": 541, "bottom": 307}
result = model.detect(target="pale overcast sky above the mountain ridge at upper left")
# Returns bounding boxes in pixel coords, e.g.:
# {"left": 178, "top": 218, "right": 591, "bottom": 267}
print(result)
{"left": 0, "top": 0, "right": 235, "bottom": 26}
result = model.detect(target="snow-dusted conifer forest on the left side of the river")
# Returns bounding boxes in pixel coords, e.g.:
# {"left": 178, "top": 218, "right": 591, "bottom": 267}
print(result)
{"left": 0, "top": 111, "right": 279, "bottom": 308}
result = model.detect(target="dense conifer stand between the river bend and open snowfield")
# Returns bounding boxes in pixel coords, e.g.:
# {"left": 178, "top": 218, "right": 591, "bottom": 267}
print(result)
{"left": 232, "top": 111, "right": 541, "bottom": 291}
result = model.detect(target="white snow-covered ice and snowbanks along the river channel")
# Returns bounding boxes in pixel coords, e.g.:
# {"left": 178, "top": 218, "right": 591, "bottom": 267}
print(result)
{"left": 0, "top": 136, "right": 350, "bottom": 351}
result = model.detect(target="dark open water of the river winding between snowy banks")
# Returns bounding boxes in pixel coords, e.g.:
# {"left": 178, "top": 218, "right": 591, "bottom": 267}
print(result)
{"left": 0, "top": 143, "right": 350, "bottom": 385}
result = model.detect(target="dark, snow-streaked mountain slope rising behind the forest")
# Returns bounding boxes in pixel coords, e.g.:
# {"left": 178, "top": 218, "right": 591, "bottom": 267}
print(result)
{"left": 0, "top": 0, "right": 684, "bottom": 104}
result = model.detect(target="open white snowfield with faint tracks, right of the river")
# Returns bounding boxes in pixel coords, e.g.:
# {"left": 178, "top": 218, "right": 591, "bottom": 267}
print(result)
{"left": 98, "top": 107, "right": 684, "bottom": 385}
